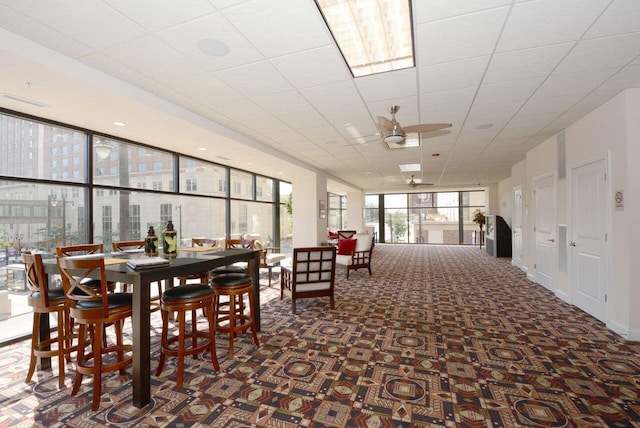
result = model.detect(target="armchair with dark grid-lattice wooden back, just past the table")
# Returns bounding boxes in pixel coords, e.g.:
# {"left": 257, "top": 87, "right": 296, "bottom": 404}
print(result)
{"left": 280, "top": 246, "right": 336, "bottom": 315}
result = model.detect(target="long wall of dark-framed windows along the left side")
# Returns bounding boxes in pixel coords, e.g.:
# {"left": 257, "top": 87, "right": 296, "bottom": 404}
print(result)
{"left": 0, "top": 110, "right": 291, "bottom": 342}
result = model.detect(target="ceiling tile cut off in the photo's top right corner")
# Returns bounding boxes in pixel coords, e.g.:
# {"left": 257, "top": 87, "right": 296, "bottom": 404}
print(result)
{"left": 585, "top": 0, "right": 640, "bottom": 38}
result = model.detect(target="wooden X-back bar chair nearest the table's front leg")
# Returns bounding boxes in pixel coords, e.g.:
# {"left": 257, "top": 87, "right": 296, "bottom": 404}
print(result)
{"left": 58, "top": 257, "right": 133, "bottom": 411}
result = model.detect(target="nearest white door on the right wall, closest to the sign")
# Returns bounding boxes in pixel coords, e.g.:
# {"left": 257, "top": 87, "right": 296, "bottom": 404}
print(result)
{"left": 569, "top": 159, "right": 609, "bottom": 322}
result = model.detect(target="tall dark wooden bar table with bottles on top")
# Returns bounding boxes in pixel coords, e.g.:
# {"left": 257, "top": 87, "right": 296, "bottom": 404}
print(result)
{"left": 41, "top": 249, "right": 260, "bottom": 408}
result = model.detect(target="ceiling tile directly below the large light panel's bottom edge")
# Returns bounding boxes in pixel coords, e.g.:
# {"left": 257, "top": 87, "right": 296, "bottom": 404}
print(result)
{"left": 354, "top": 68, "right": 418, "bottom": 101}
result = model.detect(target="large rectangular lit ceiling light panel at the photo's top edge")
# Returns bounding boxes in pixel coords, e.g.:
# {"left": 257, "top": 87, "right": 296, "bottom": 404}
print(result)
{"left": 315, "top": 0, "right": 415, "bottom": 77}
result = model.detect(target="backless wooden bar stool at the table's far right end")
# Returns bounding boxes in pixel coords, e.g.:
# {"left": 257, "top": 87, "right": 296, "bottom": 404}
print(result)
{"left": 213, "top": 273, "right": 260, "bottom": 356}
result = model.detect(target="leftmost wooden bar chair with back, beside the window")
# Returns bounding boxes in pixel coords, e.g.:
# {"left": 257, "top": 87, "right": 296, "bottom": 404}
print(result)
{"left": 22, "top": 251, "right": 76, "bottom": 388}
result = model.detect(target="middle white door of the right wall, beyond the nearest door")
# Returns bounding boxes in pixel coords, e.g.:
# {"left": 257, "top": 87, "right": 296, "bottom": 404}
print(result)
{"left": 533, "top": 175, "right": 556, "bottom": 291}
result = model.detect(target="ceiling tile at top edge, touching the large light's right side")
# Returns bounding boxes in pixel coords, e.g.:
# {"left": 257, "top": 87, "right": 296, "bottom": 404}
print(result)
{"left": 412, "top": 0, "right": 511, "bottom": 23}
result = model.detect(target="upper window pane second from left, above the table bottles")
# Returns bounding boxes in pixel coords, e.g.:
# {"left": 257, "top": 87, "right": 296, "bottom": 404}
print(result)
{"left": 93, "top": 136, "right": 175, "bottom": 191}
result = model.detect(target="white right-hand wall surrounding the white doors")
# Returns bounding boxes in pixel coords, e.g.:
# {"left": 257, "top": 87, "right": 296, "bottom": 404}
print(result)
{"left": 498, "top": 89, "right": 640, "bottom": 340}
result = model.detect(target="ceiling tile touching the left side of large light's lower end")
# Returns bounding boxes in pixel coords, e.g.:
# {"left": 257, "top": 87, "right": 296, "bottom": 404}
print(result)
{"left": 271, "top": 45, "right": 351, "bottom": 89}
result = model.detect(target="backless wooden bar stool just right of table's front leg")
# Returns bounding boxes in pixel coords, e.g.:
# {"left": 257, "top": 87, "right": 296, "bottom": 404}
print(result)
{"left": 156, "top": 284, "right": 220, "bottom": 391}
